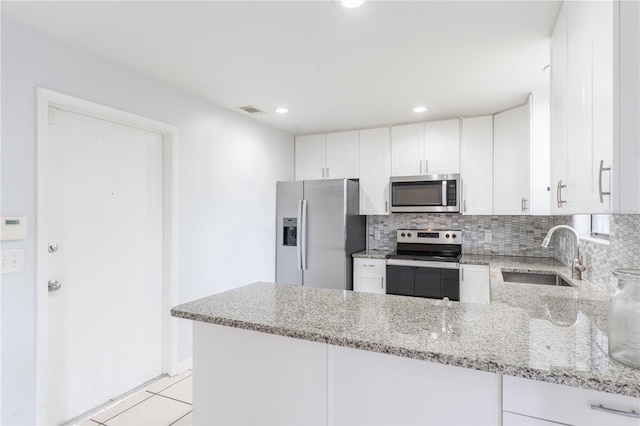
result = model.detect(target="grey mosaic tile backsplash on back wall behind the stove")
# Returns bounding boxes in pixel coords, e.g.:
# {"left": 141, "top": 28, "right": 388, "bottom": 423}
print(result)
{"left": 367, "top": 213, "right": 571, "bottom": 257}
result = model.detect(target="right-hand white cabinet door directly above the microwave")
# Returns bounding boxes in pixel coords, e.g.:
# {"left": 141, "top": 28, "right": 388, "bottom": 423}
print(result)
{"left": 424, "top": 119, "right": 460, "bottom": 175}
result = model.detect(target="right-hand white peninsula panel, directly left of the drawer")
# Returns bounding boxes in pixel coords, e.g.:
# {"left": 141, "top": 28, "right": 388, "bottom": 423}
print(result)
{"left": 329, "top": 344, "right": 500, "bottom": 425}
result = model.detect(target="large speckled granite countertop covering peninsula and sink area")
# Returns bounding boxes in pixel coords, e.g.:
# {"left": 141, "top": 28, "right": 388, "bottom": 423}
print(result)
{"left": 172, "top": 255, "right": 640, "bottom": 397}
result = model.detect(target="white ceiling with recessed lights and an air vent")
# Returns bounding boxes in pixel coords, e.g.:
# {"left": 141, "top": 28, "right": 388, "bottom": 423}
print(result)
{"left": 2, "top": 0, "right": 561, "bottom": 134}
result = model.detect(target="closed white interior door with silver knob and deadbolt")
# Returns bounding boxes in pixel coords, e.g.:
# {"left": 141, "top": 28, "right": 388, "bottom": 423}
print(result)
{"left": 39, "top": 108, "right": 163, "bottom": 424}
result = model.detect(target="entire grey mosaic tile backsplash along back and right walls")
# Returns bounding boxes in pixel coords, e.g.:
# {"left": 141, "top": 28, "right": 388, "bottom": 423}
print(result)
{"left": 367, "top": 213, "right": 640, "bottom": 288}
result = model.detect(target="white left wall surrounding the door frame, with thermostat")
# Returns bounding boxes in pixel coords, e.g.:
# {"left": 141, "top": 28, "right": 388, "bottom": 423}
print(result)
{"left": 0, "top": 19, "right": 294, "bottom": 424}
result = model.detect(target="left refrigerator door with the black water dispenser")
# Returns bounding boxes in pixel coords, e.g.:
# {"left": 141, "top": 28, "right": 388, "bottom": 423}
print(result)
{"left": 276, "top": 181, "right": 303, "bottom": 285}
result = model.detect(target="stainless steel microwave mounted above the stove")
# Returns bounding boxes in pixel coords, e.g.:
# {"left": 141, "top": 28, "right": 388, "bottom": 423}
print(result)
{"left": 389, "top": 174, "right": 461, "bottom": 213}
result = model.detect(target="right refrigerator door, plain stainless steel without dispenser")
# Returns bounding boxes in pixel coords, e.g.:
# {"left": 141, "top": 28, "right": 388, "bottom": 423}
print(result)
{"left": 300, "top": 179, "right": 351, "bottom": 290}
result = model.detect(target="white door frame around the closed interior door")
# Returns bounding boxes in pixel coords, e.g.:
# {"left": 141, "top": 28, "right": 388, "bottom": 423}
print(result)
{"left": 35, "top": 87, "right": 184, "bottom": 424}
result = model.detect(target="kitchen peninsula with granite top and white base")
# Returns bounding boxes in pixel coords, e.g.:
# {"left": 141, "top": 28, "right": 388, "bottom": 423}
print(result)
{"left": 172, "top": 258, "right": 640, "bottom": 424}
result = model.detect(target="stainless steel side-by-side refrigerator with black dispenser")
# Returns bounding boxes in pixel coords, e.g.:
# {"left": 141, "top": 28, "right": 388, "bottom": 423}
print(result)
{"left": 276, "top": 179, "right": 366, "bottom": 290}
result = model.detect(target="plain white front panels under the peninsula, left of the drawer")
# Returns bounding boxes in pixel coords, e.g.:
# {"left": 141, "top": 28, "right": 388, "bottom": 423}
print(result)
{"left": 193, "top": 321, "right": 501, "bottom": 425}
